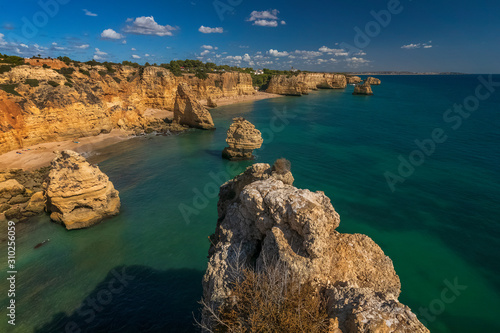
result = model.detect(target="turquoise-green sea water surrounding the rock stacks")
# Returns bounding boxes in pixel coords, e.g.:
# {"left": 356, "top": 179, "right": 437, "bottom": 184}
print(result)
{"left": 0, "top": 75, "right": 500, "bottom": 332}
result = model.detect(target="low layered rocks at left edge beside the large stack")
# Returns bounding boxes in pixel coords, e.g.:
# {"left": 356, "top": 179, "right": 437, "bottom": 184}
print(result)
{"left": 0, "top": 168, "right": 48, "bottom": 222}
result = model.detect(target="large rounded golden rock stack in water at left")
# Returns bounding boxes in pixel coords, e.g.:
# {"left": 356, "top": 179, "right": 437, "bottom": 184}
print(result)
{"left": 45, "top": 150, "right": 120, "bottom": 230}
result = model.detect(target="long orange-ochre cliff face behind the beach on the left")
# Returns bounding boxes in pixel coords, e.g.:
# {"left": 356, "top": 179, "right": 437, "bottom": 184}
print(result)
{"left": 0, "top": 62, "right": 255, "bottom": 153}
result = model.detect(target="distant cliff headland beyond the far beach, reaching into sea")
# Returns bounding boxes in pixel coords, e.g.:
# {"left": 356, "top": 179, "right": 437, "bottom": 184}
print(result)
{"left": 266, "top": 73, "right": 347, "bottom": 96}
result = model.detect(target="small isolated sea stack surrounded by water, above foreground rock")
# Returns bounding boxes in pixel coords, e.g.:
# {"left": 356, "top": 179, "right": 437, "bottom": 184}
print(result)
{"left": 222, "top": 117, "right": 264, "bottom": 160}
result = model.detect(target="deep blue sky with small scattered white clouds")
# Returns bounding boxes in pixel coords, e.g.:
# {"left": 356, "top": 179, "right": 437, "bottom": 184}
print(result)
{"left": 0, "top": 0, "right": 500, "bottom": 73}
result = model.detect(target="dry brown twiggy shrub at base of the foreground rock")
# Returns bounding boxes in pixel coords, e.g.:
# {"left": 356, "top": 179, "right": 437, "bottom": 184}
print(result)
{"left": 199, "top": 254, "right": 329, "bottom": 333}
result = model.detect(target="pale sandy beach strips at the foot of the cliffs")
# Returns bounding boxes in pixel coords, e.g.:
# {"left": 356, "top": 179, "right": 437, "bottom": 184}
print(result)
{"left": 0, "top": 92, "right": 283, "bottom": 170}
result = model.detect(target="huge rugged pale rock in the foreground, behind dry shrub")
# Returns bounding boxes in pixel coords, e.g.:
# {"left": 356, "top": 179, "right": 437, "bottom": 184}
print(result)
{"left": 203, "top": 160, "right": 428, "bottom": 333}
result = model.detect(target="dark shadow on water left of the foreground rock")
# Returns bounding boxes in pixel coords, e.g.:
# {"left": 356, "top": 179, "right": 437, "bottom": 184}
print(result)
{"left": 34, "top": 266, "right": 203, "bottom": 333}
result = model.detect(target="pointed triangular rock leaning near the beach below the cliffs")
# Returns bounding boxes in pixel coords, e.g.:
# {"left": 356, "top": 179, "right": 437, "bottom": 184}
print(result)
{"left": 174, "top": 83, "right": 215, "bottom": 129}
